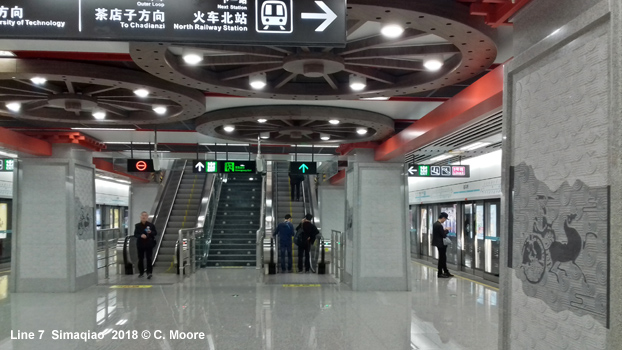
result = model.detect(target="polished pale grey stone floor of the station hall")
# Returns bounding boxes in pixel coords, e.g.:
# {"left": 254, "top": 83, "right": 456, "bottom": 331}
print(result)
{"left": 0, "top": 263, "right": 498, "bottom": 350}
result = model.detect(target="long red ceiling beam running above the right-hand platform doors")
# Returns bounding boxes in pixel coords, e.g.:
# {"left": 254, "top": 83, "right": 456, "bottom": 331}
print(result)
{"left": 376, "top": 66, "right": 504, "bottom": 161}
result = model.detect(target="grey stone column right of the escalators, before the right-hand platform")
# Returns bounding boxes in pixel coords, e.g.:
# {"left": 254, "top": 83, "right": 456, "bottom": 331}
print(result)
{"left": 342, "top": 150, "right": 411, "bottom": 291}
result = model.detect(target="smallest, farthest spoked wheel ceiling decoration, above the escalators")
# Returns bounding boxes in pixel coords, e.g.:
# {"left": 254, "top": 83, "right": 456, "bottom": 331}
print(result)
{"left": 196, "top": 106, "right": 394, "bottom": 144}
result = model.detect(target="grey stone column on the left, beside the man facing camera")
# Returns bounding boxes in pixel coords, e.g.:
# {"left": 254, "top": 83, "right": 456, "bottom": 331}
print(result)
{"left": 11, "top": 144, "right": 97, "bottom": 293}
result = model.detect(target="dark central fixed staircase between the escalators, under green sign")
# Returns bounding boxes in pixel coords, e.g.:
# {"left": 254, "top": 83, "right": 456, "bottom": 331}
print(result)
{"left": 207, "top": 174, "right": 261, "bottom": 267}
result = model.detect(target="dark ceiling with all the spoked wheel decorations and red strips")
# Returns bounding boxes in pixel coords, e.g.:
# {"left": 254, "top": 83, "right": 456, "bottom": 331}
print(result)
{"left": 0, "top": 0, "right": 512, "bottom": 157}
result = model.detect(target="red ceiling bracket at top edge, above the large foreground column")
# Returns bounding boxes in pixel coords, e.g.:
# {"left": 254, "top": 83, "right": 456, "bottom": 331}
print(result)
{"left": 458, "top": 0, "right": 531, "bottom": 28}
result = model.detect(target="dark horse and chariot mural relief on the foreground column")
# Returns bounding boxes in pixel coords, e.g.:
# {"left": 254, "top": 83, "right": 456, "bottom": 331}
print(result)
{"left": 512, "top": 163, "right": 609, "bottom": 327}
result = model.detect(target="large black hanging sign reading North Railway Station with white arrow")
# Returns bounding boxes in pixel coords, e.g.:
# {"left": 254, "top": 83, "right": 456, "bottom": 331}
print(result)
{"left": 0, "top": 0, "right": 346, "bottom": 46}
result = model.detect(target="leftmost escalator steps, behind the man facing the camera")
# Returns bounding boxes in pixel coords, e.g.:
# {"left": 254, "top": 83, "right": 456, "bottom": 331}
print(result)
{"left": 153, "top": 162, "right": 207, "bottom": 273}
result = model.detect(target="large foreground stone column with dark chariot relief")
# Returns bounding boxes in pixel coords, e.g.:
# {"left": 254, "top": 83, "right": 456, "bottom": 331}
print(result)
{"left": 499, "top": 0, "right": 622, "bottom": 350}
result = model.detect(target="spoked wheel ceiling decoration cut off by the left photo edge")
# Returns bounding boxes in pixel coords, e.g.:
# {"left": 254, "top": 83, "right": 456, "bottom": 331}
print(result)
{"left": 0, "top": 59, "right": 205, "bottom": 125}
